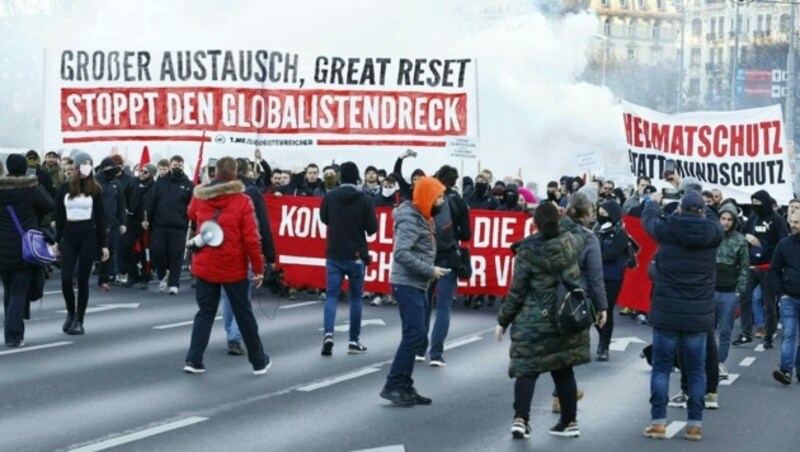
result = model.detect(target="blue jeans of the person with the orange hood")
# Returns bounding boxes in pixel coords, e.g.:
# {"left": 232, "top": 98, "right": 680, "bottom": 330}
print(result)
{"left": 386, "top": 285, "right": 427, "bottom": 387}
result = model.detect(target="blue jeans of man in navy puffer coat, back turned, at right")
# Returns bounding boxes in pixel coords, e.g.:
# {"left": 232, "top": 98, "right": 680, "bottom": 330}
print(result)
{"left": 650, "top": 328, "right": 708, "bottom": 427}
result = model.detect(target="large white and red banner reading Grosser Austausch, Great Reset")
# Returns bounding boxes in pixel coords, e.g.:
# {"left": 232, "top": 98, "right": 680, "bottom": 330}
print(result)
{"left": 45, "top": 49, "right": 478, "bottom": 150}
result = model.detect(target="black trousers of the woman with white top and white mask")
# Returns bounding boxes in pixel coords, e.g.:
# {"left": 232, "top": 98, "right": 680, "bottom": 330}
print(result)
{"left": 61, "top": 220, "right": 98, "bottom": 322}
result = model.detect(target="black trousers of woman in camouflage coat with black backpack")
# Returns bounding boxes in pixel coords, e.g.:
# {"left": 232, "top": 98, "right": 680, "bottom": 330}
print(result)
{"left": 514, "top": 367, "right": 578, "bottom": 424}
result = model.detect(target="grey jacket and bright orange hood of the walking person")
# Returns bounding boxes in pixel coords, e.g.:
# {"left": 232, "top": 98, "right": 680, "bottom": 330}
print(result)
{"left": 389, "top": 177, "right": 444, "bottom": 290}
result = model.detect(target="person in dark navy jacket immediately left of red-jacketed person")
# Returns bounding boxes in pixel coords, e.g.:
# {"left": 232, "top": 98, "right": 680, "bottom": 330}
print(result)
{"left": 142, "top": 155, "right": 194, "bottom": 295}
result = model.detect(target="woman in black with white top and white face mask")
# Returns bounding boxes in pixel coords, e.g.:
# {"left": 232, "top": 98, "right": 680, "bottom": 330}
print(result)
{"left": 56, "top": 152, "right": 109, "bottom": 335}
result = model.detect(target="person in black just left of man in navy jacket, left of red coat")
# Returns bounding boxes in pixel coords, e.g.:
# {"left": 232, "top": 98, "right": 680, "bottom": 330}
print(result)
{"left": 122, "top": 163, "right": 157, "bottom": 290}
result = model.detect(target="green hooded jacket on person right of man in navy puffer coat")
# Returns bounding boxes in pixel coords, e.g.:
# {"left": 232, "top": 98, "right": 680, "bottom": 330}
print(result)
{"left": 716, "top": 204, "right": 750, "bottom": 294}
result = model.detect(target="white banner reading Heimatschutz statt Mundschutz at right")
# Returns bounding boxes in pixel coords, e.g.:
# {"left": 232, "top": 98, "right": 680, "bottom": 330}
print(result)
{"left": 623, "top": 103, "right": 793, "bottom": 205}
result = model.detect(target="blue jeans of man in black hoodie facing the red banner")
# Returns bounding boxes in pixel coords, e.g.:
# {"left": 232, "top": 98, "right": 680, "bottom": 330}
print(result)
{"left": 323, "top": 259, "right": 364, "bottom": 342}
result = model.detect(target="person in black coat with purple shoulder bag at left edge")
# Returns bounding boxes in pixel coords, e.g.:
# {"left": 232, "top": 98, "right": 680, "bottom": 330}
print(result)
{"left": 0, "top": 154, "right": 54, "bottom": 347}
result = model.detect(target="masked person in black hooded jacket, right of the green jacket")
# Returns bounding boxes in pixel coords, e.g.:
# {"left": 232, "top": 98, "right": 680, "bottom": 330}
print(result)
{"left": 733, "top": 190, "right": 789, "bottom": 349}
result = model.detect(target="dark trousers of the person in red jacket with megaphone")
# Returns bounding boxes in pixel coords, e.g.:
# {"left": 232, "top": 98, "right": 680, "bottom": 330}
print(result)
{"left": 186, "top": 278, "right": 269, "bottom": 370}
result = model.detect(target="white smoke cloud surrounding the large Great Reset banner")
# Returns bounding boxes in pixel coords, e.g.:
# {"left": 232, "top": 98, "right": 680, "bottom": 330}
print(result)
{"left": 0, "top": 0, "right": 623, "bottom": 185}
